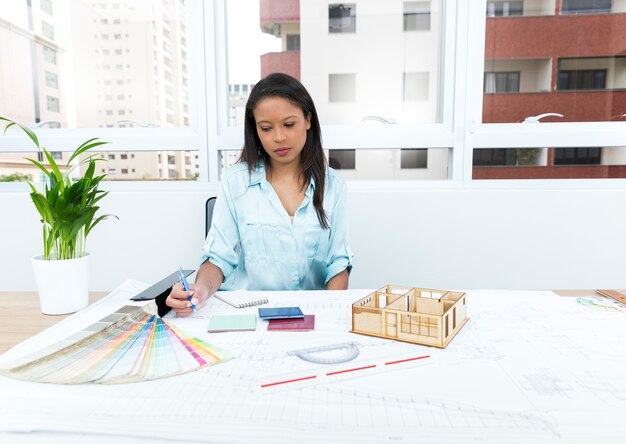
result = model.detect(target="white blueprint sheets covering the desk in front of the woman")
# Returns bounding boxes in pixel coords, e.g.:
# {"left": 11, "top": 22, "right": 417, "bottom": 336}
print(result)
{"left": 0, "top": 281, "right": 626, "bottom": 443}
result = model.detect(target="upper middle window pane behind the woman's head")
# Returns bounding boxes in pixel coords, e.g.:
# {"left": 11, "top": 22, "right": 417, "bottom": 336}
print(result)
{"left": 227, "top": 0, "right": 443, "bottom": 126}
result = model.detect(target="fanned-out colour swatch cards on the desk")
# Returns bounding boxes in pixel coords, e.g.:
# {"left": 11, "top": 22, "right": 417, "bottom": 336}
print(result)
{"left": 0, "top": 303, "right": 229, "bottom": 384}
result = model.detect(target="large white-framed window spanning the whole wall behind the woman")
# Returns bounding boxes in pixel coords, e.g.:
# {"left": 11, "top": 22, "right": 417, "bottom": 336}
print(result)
{"left": 0, "top": 0, "right": 626, "bottom": 186}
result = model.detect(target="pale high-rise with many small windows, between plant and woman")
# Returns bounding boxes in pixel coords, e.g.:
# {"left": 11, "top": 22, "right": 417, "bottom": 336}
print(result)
{"left": 71, "top": 0, "right": 199, "bottom": 180}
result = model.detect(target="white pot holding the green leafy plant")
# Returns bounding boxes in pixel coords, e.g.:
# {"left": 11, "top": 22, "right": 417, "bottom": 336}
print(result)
{"left": 32, "top": 253, "right": 90, "bottom": 314}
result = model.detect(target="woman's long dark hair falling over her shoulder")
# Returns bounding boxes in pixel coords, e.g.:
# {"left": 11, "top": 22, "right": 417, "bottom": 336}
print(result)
{"left": 239, "top": 73, "right": 329, "bottom": 229}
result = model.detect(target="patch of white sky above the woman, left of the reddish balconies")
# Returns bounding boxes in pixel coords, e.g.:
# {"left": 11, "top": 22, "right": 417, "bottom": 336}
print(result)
{"left": 227, "top": 0, "right": 281, "bottom": 84}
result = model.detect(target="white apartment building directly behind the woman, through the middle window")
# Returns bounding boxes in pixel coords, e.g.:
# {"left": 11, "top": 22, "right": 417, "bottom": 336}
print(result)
{"left": 264, "top": 0, "right": 448, "bottom": 180}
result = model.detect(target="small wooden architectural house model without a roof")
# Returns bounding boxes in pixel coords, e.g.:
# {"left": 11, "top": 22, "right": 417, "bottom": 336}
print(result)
{"left": 351, "top": 285, "right": 468, "bottom": 348}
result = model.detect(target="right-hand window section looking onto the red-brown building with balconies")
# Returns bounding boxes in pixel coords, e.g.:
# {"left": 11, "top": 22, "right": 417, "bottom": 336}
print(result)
{"left": 480, "top": 0, "right": 626, "bottom": 179}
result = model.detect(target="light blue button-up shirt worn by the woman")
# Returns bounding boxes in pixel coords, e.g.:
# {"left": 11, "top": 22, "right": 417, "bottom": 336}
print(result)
{"left": 201, "top": 163, "right": 352, "bottom": 290}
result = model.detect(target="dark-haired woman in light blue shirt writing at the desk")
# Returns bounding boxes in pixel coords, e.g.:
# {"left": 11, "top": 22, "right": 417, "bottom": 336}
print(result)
{"left": 166, "top": 73, "right": 352, "bottom": 316}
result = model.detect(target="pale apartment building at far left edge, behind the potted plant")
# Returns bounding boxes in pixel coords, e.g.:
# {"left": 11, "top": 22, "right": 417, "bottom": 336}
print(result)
{"left": 0, "top": 0, "right": 67, "bottom": 181}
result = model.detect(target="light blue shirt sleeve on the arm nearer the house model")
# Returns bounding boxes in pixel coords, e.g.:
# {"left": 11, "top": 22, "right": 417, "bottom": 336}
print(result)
{"left": 324, "top": 181, "right": 353, "bottom": 283}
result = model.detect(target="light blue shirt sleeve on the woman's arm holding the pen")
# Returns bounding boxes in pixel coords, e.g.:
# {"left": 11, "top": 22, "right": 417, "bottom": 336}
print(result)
{"left": 200, "top": 180, "right": 239, "bottom": 280}
